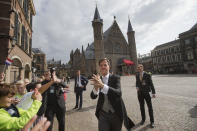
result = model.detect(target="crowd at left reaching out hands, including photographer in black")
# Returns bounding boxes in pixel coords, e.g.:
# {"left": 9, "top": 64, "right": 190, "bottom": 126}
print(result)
{"left": 0, "top": 69, "right": 68, "bottom": 131}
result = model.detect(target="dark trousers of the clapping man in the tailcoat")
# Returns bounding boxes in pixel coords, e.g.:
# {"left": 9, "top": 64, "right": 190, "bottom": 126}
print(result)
{"left": 98, "top": 110, "right": 122, "bottom": 131}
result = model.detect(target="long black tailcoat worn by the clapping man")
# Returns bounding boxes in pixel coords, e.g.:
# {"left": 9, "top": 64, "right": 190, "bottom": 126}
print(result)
{"left": 90, "top": 74, "right": 134, "bottom": 129}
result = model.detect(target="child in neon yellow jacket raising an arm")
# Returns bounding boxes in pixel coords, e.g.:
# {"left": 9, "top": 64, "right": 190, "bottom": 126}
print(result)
{"left": 0, "top": 84, "right": 42, "bottom": 131}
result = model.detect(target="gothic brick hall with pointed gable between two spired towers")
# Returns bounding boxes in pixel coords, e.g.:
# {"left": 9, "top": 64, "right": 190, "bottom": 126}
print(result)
{"left": 69, "top": 7, "right": 137, "bottom": 76}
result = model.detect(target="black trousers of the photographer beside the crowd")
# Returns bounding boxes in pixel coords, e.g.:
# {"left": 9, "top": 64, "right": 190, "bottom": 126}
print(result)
{"left": 45, "top": 105, "right": 66, "bottom": 131}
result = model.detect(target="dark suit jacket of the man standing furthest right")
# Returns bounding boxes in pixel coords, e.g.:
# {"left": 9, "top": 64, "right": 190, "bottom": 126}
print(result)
{"left": 136, "top": 72, "right": 155, "bottom": 94}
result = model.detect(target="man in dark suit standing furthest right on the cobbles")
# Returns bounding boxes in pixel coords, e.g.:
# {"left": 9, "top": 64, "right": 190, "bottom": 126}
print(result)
{"left": 136, "top": 64, "right": 155, "bottom": 128}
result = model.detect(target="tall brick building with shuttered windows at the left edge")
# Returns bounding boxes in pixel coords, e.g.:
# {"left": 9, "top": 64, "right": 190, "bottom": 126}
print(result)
{"left": 0, "top": 0, "right": 35, "bottom": 82}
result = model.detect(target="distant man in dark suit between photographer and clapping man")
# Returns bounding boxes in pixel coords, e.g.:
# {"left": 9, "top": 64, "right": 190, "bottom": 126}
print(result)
{"left": 73, "top": 70, "right": 88, "bottom": 110}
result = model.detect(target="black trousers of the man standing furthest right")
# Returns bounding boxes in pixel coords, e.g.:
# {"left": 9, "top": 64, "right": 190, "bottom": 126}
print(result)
{"left": 138, "top": 91, "right": 154, "bottom": 122}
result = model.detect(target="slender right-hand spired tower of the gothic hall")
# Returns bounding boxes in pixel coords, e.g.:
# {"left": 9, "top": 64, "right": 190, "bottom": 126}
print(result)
{"left": 127, "top": 19, "right": 138, "bottom": 73}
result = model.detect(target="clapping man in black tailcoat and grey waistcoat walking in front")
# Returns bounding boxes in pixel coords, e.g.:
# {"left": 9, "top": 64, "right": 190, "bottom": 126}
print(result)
{"left": 90, "top": 58, "right": 134, "bottom": 131}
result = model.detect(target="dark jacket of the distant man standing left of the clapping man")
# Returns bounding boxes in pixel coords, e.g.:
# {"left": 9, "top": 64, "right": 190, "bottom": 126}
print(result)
{"left": 74, "top": 75, "right": 88, "bottom": 93}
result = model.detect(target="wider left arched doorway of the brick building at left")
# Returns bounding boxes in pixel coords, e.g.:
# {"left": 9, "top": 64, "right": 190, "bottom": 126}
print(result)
{"left": 10, "top": 58, "right": 22, "bottom": 83}
